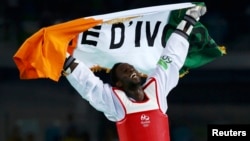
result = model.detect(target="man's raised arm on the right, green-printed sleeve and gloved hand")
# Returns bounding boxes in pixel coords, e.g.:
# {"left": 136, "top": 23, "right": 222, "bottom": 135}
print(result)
{"left": 152, "top": 6, "right": 206, "bottom": 110}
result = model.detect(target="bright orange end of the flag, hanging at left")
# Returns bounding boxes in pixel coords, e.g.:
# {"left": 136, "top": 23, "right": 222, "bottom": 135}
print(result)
{"left": 14, "top": 18, "right": 102, "bottom": 81}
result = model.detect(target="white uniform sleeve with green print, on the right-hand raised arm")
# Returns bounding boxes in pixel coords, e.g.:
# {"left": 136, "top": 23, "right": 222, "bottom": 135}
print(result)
{"left": 149, "top": 33, "right": 189, "bottom": 112}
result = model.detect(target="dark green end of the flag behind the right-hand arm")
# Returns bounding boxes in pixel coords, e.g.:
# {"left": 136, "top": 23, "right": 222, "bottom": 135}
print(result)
{"left": 166, "top": 6, "right": 226, "bottom": 77}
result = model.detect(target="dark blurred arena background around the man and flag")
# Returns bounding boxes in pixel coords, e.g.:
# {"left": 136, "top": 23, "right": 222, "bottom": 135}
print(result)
{"left": 0, "top": 0, "right": 250, "bottom": 141}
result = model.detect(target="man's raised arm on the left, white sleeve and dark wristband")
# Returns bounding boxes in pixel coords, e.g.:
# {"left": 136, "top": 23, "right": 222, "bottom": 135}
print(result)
{"left": 62, "top": 55, "right": 124, "bottom": 121}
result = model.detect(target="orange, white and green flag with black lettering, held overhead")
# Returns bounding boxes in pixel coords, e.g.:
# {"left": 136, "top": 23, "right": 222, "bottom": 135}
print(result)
{"left": 13, "top": 3, "right": 225, "bottom": 81}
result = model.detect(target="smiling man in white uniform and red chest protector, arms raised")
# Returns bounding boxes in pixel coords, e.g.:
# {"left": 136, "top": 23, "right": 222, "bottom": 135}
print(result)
{"left": 63, "top": 6, "right": 206, "bottom": 141}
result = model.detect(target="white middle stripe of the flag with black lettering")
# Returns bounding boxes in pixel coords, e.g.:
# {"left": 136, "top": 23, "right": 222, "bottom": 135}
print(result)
{"left": 73, "top": 3, "right": 194, "bottom": 74}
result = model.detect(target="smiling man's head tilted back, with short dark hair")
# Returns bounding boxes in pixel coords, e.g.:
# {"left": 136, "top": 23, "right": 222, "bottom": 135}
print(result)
{"left": 116, "top": 63, "right": 141, "bottom": 88}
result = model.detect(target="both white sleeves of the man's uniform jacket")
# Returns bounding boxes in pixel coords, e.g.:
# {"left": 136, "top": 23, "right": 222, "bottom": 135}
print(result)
{"left": 67, "top": 33, "right": 189, "bottom": 122}
